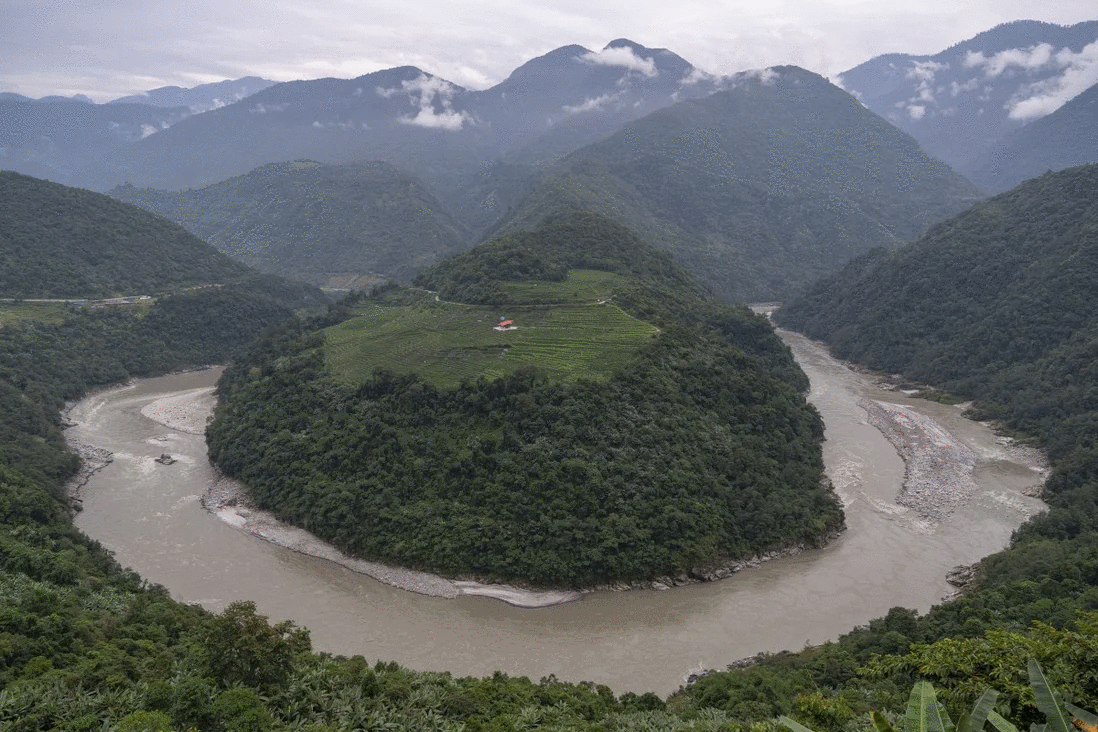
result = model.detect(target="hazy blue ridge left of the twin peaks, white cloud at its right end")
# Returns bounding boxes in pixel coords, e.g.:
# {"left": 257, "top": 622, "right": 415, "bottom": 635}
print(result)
{"left": 86, "top": 67, "right": 483, "bottom": 189}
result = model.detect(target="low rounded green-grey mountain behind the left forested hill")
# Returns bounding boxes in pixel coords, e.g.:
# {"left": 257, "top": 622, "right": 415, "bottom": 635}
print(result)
{"left": 110, "top": 160, "right": 471, "bottom": 286}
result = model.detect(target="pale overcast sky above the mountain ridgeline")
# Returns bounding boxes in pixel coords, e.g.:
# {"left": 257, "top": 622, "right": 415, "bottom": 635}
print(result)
{"left": 0, "top": 0, "right": 1098, "bottom": 102}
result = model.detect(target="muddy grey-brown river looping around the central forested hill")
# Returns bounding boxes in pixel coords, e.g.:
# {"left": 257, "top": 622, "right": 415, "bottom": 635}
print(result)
{"left": 69, "top": 334, "right": 1042, "bottom": 696}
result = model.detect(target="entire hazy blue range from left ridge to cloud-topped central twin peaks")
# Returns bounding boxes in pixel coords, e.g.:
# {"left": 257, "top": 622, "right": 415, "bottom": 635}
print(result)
{"left": 53, "top": 40, "right": 719, "bottom": 196}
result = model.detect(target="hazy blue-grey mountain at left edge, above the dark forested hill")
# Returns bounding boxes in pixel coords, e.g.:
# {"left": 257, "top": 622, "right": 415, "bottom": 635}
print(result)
{"left": 0, "top": 98, "right": 190, "bottom": 184}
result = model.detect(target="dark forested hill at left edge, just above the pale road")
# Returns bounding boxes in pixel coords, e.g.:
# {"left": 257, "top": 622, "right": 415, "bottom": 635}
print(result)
{"left": 0, "top": 172, "right": 259, "bottom": 297}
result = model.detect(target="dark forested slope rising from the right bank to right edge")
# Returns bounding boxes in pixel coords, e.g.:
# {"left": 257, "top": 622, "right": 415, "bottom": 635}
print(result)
{"left": 777, "top": 165, "right": 1098, "bottom": 452}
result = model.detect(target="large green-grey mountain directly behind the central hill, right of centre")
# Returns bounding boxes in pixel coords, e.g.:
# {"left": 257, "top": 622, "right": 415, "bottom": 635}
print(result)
{"left": 495, "top": 67, "right": 979, "bottom": 301}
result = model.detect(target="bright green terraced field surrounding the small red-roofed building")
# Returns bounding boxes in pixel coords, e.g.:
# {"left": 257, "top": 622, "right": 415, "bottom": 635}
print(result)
{"left": 324, "top": 272, "right": 658, "bottom": 388}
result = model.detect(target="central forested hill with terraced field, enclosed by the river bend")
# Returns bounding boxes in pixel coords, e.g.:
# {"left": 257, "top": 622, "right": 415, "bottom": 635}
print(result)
{"left": 206, "top": 214, "right": 843, "bottom": 588}
